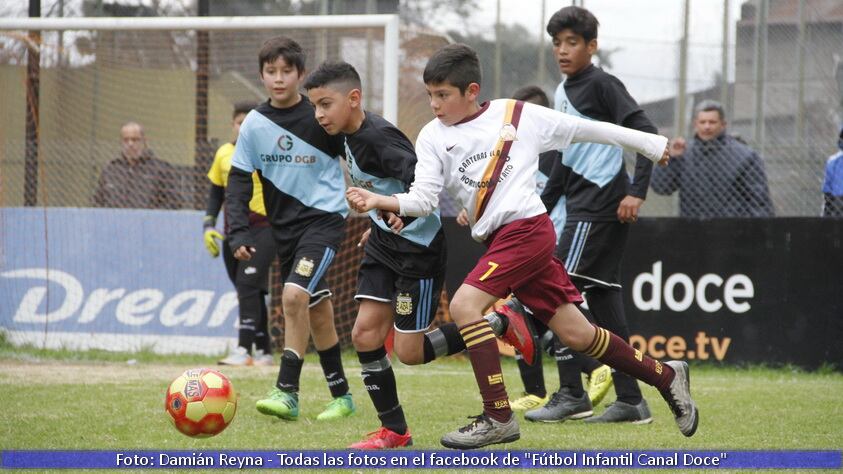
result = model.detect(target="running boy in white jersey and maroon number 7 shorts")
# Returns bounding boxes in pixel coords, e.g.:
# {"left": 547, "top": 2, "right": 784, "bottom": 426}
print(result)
{"left": 346, "top": 44, "right": 698, "bottom": 449}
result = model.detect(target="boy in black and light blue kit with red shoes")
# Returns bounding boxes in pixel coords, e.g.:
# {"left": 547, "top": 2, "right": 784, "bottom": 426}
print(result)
{"left": 304, "top": 62, "right": 535, "bottom": 449}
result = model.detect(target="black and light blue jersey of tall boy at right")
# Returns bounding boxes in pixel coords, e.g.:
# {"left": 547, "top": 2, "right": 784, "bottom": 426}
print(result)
{"left": 542, "top": 65, "right": 657, "bottom": 221}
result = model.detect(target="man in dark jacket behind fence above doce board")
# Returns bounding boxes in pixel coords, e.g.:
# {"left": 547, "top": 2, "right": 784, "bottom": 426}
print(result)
{"left": 651, "top": 100, "right": 774, "bottom": 219}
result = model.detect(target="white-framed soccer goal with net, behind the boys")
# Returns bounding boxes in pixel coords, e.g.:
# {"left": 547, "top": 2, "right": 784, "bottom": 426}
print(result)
{"left": 0, "top": 15, "right": 454, "bottom": 354}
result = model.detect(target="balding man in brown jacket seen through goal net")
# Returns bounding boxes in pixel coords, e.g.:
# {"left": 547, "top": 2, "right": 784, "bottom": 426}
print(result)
{"left": 93, "top": 122, "right": 180, "bottom": 209}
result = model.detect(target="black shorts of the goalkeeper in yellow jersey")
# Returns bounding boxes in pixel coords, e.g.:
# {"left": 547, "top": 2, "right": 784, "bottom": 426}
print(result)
{"left": 222, "top": 226, "right": 276, "bottom": 293}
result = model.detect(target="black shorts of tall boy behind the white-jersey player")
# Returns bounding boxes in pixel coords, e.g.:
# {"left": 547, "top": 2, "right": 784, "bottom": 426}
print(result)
{"left": 556, "top": 220, "right": 629, "bottom": 291}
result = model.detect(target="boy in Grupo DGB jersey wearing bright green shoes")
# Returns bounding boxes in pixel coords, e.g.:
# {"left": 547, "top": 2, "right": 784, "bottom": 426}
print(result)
{"left": 226, "top": 37, "right": 354, "bottom": 420}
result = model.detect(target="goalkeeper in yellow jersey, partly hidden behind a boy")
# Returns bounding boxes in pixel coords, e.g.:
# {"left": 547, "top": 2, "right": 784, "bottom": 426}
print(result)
{"left": 202, "top": 103, "right": 275, "bottom": 365}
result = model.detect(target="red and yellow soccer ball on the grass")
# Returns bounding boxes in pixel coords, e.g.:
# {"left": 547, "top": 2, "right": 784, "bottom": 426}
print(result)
{"left": 164, "top": 369, "right": 237, "bottom": 438}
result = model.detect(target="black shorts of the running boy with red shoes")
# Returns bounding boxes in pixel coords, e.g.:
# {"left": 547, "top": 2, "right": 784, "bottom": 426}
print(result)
{"left": 354, "top": 255, "right": 445, "bottom": 333}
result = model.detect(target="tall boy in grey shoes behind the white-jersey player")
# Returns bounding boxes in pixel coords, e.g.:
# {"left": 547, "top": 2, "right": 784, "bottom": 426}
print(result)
{"left": 525, "top": 6, "right": 657, "bottom": 424}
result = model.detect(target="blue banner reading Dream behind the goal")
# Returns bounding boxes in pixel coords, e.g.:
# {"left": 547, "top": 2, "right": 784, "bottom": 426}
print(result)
{"left": 0, "top": 208, "right": 237, "bottom": 354}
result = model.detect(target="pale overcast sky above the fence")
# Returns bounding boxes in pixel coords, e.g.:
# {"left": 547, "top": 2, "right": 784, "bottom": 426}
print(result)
{"left": 442, "top": 0, "right": 745, "bottom": 102}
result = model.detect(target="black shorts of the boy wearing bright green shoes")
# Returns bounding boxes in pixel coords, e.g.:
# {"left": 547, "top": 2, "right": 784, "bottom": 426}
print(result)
{"left": 277, "top": 219, "right": 345, "bottom": 307}
